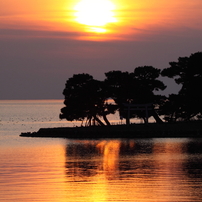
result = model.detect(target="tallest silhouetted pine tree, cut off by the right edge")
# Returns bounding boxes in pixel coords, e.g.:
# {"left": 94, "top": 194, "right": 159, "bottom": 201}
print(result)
{"left": 162, "top": 52, "right": 202, "bottom": 121}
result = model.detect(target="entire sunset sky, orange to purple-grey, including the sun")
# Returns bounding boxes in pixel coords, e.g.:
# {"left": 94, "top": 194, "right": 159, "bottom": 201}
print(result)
{"left": 0, "top": 0, "right": 202, "bottom": 99}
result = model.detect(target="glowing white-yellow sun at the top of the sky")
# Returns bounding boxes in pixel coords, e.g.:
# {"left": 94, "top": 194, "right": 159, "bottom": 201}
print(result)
{"left": 74, "top": 0, "right": 117, "bottom": 33}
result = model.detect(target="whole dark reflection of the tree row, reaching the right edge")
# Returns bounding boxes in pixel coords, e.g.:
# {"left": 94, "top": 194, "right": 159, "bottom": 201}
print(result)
{"left": 66, "top": 140, "right": 202, "bottom": 179}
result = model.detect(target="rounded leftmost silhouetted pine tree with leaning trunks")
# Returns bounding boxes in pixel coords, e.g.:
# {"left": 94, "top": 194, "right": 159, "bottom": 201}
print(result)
{"left": 60, "top": 74, "right": 115, "bottom": 125}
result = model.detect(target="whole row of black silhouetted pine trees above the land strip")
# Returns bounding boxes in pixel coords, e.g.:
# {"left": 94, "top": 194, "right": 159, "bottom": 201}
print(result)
{"left": 60, "top": 52, "right": 202, "bottom": 126}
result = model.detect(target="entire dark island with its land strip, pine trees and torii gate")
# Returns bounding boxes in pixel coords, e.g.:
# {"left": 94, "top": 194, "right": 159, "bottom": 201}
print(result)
{"left": 21, "top": 52, "right": 202, "bottom": 139}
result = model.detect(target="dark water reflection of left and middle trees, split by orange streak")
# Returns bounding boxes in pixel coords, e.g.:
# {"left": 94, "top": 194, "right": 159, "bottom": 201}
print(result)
{"left": 66, "top": 140, "right": 154, "bottom": 180}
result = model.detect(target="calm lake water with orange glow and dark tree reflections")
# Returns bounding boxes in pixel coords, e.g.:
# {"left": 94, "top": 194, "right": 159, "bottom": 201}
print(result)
{"left": 0, "top": 100, "right": 202, "bottom": 202}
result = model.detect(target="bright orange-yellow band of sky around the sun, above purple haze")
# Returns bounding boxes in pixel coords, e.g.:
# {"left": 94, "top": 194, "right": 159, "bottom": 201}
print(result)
{"left": 0, "top": 0, "right": 202, "bottom": 40}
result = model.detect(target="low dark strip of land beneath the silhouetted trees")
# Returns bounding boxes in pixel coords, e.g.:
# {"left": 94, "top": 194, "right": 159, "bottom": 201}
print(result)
{"left": 20, "top": 121, "right": 202, "bottom": 139}
